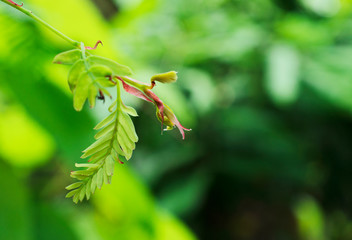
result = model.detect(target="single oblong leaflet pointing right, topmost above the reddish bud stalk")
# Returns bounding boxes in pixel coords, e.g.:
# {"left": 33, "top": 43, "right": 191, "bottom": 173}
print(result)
{"left": 87, "top": 56, "right": 133, "bottom": 76}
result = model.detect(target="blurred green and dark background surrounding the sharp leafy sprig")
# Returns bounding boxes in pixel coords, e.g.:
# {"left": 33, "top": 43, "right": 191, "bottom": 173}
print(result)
{"left": 0, "top": 0, "right": 352, "bottom": 240}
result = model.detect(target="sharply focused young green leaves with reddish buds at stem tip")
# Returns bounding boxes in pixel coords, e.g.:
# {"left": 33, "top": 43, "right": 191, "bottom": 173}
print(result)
{"left": 54, "top": 43, "right": 188, "bottom": 203}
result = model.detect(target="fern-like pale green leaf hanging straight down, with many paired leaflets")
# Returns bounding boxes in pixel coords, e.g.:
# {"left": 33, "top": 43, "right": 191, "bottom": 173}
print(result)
{"left": 66, "top": 100, "right": 138, "bottom": 203}
